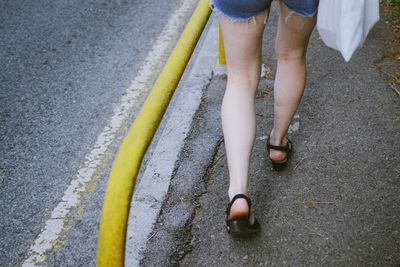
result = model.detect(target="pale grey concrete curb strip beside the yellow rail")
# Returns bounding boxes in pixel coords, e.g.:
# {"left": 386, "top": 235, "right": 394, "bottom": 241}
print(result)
{"left": 125, "top": 16, "right": 218, "bottom": 266}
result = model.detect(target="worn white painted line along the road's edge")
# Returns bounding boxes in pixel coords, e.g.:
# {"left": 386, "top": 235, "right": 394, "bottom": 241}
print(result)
{"left": 22, "top": 0, "right": 195, "bottom": 267}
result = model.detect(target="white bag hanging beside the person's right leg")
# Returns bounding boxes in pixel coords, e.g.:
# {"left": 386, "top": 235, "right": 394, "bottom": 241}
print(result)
{"left": 317, "top": 0, "right": 379, "bottom": 62}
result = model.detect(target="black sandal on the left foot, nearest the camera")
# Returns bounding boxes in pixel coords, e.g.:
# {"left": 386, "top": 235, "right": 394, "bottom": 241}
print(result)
{"left": 226, "top": 194, "right": 261, "bottom": 237}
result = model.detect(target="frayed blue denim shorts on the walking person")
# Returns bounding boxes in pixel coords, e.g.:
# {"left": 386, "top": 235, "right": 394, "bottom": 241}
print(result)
{"left": 211, "top": 0, "right": 320, "bottom": 21}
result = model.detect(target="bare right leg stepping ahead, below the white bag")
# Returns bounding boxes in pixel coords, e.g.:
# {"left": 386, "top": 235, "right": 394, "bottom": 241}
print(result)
{"left": 270, "top": 1, "right": 316, "bottom": 160}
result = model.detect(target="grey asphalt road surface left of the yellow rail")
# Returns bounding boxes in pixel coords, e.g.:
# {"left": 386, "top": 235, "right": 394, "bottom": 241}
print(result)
{"left": 0, "top": 0, "right": 196, "bottom": 266}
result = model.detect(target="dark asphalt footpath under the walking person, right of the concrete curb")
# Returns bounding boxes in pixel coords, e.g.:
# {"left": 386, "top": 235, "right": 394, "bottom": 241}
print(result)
{"left": 142, "top": 4, "right": 400, "bottom": 266}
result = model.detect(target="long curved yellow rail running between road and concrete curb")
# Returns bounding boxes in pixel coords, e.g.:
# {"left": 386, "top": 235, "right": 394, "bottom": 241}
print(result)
{"left": 97, "top": 0, "right": 211, "bottom": 267}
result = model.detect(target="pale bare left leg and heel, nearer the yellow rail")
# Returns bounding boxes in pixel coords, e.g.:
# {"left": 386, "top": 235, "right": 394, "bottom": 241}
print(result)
{"left": 220, "top": 14, "right": 265, "bottom": 217}
